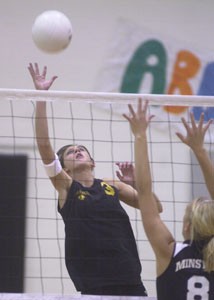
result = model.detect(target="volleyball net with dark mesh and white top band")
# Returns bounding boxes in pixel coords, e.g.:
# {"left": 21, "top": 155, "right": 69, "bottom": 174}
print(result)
{"left": 0, "top": 89, "right": 214, "bottom": 299}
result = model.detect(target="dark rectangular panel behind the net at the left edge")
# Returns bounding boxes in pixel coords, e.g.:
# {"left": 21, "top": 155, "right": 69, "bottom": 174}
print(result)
{"left": 0, "top": 155, "right": 27, "bottom": 293}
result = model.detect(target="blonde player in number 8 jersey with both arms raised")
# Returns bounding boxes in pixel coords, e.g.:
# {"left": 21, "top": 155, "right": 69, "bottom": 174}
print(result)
{"left": 124, "top": 99, "right": 214, "bottom": 300}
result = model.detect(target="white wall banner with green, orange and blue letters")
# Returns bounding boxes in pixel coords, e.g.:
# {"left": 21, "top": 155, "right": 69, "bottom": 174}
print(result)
{"left": 95, "top": 20, "right": 214, "bottom": 138}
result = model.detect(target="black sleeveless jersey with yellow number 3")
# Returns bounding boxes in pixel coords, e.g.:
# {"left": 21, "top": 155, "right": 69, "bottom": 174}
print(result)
{"left": 58, "top": 179, "right": 141, "bottom": 291}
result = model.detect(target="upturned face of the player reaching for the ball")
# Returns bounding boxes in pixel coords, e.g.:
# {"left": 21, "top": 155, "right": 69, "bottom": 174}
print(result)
{"left": 64, "top": 145, "right": 94, "bottom": 170}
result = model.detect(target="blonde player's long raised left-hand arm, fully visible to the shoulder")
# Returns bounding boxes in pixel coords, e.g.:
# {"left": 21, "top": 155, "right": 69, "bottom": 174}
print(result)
{"left": 124, "top": 99, "right": 174, "bottom": 274}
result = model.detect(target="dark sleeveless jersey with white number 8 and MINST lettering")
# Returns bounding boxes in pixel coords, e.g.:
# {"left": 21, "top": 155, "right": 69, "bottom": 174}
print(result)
{"left": 157, "top": 242, "right": 214, "bottom": 300}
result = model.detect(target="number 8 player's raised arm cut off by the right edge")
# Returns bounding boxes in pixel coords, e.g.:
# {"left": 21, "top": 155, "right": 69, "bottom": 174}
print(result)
{"left": 176, "top": 112, "right": 214, "bottom": 199}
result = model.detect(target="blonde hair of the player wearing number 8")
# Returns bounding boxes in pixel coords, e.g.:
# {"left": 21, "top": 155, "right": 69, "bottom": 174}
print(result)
{"left": 190, "top": 197, "right": 214, "bottom": 272}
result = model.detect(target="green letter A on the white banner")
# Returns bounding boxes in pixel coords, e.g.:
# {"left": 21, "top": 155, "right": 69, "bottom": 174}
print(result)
{"left": 120, "top": 40, "right": 167, "bottom": 94}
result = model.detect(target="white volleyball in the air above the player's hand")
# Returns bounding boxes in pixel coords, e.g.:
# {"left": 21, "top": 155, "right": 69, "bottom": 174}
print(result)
{"left": 32, "top": 10, "right": 72, "bottom": 53}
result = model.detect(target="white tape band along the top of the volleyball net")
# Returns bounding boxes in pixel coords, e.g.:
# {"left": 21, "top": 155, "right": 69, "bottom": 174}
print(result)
{"left": 0, "top": 89, "right": 214, "bottom": 106}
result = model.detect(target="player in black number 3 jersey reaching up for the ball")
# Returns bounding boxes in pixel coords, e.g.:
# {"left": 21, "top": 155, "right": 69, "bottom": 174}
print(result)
{"left": 28, "top": 64, "right": 162, "bottom": 296}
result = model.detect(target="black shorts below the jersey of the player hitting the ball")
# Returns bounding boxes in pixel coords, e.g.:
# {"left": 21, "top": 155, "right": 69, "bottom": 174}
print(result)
{"left": 81, "top": 284, "right": 148, "bottom": 296}
